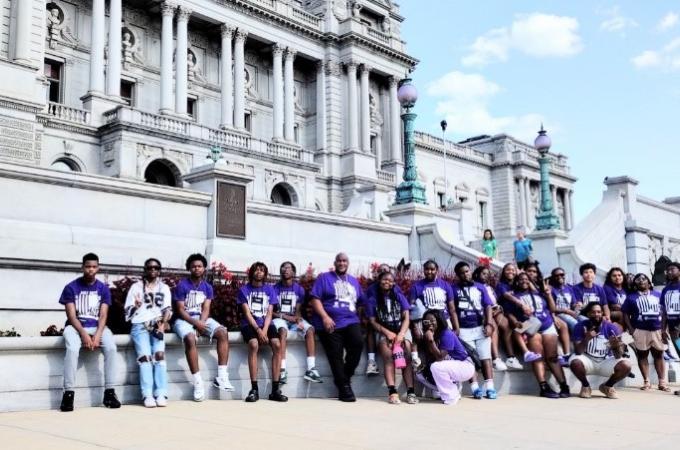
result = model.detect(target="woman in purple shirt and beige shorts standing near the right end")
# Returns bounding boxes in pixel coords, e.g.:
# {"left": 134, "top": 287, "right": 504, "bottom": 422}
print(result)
{"left": 621, "top": 273, "right": 671, "bottom": 392}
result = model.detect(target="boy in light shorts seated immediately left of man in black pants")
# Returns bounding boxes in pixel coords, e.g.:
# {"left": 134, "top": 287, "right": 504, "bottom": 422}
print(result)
{"left": 273, "top": 261, "right": 323, "bottom": 384}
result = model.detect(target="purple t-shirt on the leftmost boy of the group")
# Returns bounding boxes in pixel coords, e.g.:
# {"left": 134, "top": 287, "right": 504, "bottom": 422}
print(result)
{"left": 59, "top": 277, "right": 111, "bottom": 328}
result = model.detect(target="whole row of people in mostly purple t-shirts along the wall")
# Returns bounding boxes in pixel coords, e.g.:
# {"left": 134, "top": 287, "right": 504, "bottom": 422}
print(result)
{"left": 59, "top": 253, "right": 680, "bottom": 411}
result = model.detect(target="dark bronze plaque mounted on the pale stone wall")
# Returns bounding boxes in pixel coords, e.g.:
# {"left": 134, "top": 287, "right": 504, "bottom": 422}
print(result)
{"left": 216, "top": 181, "right": 246, "bottom": 239}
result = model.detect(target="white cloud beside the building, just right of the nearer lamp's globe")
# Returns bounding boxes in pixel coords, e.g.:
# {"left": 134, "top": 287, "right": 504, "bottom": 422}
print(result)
{"left": 426, "top": 71, "right": 543, "bottom": 142}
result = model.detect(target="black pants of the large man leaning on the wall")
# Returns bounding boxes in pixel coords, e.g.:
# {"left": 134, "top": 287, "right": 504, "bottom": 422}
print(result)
{"left": 319, "top": 323, "right": 364, "bottom": 387}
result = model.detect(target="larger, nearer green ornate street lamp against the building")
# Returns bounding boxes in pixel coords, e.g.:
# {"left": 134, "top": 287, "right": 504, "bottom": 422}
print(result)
{"left": 394, "top": 78, "right": 427, "bottom": 205}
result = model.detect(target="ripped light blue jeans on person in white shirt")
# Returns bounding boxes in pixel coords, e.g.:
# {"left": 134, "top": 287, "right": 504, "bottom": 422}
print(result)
{"left": 130, "top": 323, "right": 168, "bottom": 398}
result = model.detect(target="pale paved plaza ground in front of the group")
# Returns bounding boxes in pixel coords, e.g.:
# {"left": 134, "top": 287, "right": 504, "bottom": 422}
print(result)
{"left": 0, "top": 389, "right": 680, "bottom": 450}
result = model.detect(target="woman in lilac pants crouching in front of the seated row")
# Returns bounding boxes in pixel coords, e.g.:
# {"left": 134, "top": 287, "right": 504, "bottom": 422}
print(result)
{"left": 423, "top": 310, "right": 475, "bottom": 405}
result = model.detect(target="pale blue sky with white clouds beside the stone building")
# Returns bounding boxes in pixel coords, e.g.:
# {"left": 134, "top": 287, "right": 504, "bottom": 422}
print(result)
{"left": 400, "top": 0, "right": 680, "bottom": 220}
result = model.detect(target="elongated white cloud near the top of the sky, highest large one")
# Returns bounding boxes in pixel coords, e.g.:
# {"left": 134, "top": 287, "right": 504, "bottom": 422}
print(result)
{"left": 461, "top": 13, "right": 583, "bottom": 67}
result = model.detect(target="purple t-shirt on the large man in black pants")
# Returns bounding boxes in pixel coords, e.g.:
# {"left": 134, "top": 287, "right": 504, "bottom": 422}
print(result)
{"left": 310, "top": 271, "right": 364, "bottom": 330}
